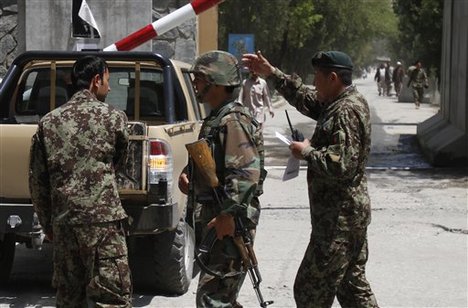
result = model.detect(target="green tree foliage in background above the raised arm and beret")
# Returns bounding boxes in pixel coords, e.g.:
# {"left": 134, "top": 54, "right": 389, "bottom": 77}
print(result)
{"left": 219, "top": 0, "right": 400, "bottom": 76}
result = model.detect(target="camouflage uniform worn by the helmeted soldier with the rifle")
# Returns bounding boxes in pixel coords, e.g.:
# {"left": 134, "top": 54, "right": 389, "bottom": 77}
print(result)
{"left": 193, "top": 101, "right": 261, "bottom": 307}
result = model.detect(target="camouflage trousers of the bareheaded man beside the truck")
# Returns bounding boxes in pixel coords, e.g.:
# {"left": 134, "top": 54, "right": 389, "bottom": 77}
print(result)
{"left": 53, "top": 222, "right": 132, "bottom": 308}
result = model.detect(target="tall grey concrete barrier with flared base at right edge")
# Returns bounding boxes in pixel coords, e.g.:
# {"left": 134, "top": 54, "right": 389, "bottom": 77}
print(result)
{"left": 417, "top": 0, "right": 468, "bottom": 167}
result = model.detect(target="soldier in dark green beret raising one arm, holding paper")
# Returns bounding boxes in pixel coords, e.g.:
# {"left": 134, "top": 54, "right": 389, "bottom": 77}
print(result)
{"left": 243, "top": 51, "right": 377, "bottom": 307}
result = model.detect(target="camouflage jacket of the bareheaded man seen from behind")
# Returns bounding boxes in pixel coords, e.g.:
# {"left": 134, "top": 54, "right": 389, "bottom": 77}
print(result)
{"left": 29, "top": 90, "right": 128, "bottom": 231}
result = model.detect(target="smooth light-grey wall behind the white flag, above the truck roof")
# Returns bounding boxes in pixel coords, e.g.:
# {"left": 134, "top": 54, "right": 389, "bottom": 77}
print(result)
{"left": 24, "top": 0, "right": 152, "bottom": 50}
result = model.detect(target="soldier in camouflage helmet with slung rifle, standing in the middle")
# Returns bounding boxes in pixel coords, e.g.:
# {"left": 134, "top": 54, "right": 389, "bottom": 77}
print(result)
{"left": 179, "top": 51, "right": 263, "bottom": 307}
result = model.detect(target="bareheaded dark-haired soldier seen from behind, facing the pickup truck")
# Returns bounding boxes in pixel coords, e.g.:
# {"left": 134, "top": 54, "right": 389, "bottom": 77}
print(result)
{"left": 29, "top": 56, "right": 132, "bottom": 308}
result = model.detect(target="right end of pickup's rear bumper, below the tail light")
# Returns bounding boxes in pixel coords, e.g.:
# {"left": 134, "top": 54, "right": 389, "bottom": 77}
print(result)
{"left": 125, "top": 203, "right": 180, "bottom": 234}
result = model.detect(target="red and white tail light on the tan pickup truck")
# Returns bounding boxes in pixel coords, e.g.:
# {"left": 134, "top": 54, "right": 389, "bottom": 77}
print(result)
{"left": 148, "top": 139, "right": 174, "bottom": 203}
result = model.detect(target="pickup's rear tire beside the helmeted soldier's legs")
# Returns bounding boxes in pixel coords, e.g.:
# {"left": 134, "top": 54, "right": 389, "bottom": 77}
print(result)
{"left": 129, "top": 221, "right": 195, "bottom": 295}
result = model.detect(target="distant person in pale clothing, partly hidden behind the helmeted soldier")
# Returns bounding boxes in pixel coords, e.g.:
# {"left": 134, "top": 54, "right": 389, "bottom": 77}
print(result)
{"left": 239, "top": 72, "right": 275, "bottom": 129}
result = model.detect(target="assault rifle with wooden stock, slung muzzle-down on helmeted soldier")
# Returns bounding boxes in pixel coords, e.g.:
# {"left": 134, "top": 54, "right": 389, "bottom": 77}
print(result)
{"left": 185, "top": 139, "right": 273, "bottom": 308}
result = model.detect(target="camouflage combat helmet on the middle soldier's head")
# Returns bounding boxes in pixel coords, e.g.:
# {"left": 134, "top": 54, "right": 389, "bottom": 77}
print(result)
{"left": 191, "top": 50, "right": 241, "bottom": 86}
